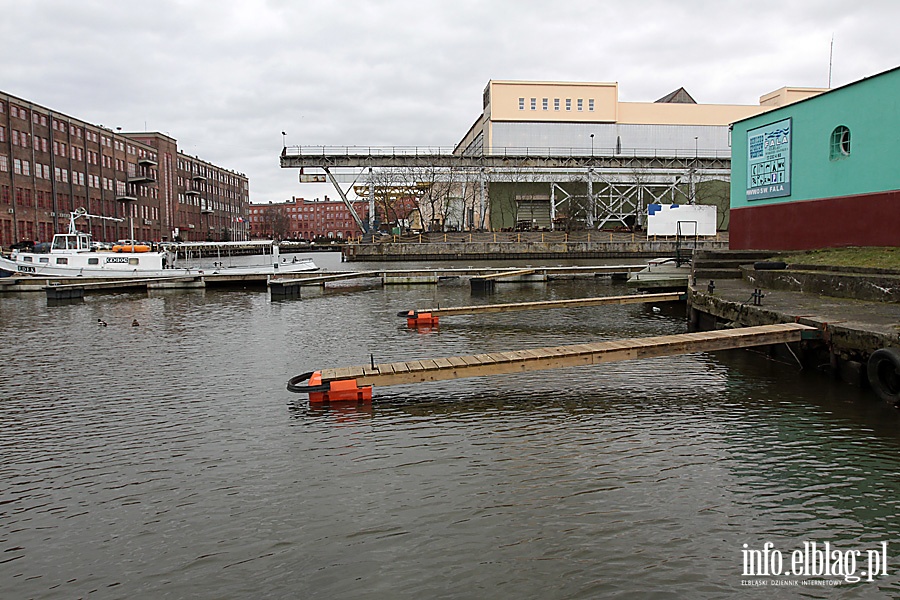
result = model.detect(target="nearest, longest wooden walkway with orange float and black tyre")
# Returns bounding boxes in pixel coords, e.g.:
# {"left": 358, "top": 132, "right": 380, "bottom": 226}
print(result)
{"left": 288, "top": 323, "right": 818, "bottom": 402}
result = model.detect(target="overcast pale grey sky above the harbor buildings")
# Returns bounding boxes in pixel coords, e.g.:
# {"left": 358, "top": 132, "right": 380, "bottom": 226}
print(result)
{"left": 0, "top": 0, "right": 900, "bottom": 202}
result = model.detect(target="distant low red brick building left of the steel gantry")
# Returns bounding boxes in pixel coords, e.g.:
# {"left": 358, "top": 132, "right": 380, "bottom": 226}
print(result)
{"left": 249, "top": 196, "right": 369, "bottom": 240}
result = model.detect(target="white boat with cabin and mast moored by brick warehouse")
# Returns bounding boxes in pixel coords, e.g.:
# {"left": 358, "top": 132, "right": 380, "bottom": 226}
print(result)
{"left": 0, "top": 209, "right": 318, "bottom": 278}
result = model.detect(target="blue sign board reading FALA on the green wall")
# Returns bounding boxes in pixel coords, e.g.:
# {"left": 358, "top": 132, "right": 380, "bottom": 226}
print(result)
{"left": 747, "top": 118, "right": 791, "bottom": 200}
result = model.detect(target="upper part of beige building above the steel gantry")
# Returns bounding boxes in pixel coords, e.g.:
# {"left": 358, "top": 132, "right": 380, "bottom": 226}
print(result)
{"left": 457, "top": 80, "right": 825, "bottom": 156}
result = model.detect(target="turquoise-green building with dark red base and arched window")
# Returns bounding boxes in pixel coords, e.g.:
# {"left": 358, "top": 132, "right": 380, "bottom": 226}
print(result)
{"left": 730, "top": 67, "right": 900, "bottom": 250}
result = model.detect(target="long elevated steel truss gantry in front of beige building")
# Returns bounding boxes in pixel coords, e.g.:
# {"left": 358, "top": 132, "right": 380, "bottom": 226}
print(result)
{"left": 280, "top": 147, "right": 731, "bottom": 229}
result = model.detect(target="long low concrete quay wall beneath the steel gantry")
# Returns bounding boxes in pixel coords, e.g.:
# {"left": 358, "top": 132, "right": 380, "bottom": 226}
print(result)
{"left": 343, "top": 240, "right": 728, "bottom": 261}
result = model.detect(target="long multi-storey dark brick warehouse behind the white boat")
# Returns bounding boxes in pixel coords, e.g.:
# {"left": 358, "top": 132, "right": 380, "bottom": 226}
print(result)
{"left": 0, "top": 92, "right": 249, "bottom": 246}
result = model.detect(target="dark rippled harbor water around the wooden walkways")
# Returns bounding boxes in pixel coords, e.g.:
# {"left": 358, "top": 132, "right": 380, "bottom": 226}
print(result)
{"left": 0, "top": 254, "right": 900, "bottom": 599}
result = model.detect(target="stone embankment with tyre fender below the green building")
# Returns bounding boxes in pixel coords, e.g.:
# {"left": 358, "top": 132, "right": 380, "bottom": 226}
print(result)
{"left": 688, "top": 252, "right": 900, "bottom": 399}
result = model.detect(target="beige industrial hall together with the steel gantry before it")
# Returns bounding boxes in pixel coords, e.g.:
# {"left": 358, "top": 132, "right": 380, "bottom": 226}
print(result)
{"left": 281, "top": 80, "right": 825, "bottom": 235}
